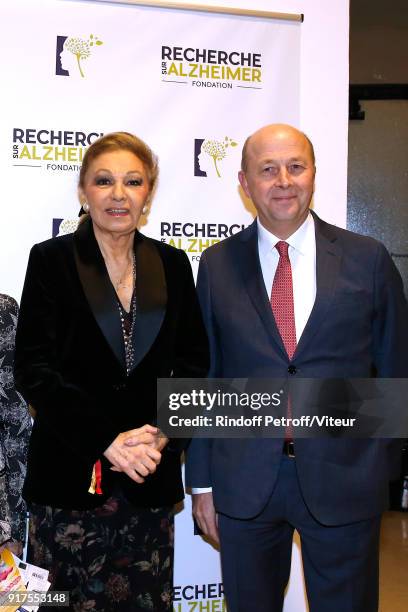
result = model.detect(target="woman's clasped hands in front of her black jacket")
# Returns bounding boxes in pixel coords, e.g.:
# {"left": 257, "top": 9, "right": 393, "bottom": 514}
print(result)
{"left": 103, "top": 425, "right": 161, "bottom": 484}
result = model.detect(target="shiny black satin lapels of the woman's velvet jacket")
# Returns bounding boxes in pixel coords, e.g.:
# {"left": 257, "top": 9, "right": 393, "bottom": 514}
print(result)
{"left": 74, "top": 220, "right": 167, "bottom": 369}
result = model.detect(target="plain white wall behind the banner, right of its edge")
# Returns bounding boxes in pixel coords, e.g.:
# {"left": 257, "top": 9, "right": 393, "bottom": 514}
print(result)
{"left": 169, "top": 0, "right": 349, "bottom": 227}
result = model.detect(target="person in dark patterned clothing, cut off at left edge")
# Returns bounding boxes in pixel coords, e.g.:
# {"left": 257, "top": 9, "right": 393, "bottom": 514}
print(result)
{"left": 0, "top": 294, "right": 31, "bottom": 556}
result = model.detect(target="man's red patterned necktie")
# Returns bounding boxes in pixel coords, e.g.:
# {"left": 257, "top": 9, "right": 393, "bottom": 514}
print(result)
{"left": 271, "top": 240, "right": 296, "bottom": 441}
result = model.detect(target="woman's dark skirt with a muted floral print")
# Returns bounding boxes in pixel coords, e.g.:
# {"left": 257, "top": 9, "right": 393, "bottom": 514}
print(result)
{"left": 28, "top": 493, "right": 174, "bottom": 612}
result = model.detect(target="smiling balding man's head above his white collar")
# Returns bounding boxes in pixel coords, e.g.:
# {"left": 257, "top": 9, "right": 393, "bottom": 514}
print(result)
{"left": 239, "top": 125, "right": 315, "bottom": 239}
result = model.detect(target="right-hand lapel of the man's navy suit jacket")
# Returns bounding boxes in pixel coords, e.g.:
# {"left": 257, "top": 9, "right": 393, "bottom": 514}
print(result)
{"left": 293, "top": 212, "right": 342, "bottom": 360}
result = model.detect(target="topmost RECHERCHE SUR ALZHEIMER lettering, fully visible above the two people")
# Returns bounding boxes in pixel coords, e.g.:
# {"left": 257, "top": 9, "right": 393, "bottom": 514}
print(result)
{"left": 161, "top": 45, "right": 262, "bottom": 89}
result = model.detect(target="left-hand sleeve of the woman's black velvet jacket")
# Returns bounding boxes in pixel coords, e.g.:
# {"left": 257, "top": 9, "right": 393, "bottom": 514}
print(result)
{"left": 14, "top": 245, "right": 117, "bottom": 461}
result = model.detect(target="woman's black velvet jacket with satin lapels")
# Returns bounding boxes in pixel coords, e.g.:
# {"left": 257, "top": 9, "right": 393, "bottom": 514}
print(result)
{"left": 15, "top": 220, "right": 208, "bottom": 509}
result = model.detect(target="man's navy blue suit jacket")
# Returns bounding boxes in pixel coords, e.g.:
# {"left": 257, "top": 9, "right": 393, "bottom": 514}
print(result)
{"left": 186, "top": 215, "right": 408, "bottom": 525}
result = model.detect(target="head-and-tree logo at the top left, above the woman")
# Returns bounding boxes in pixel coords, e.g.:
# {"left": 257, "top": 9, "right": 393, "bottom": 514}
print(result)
{"left": 55, "top": 34, "right": 103, "bottom": 78}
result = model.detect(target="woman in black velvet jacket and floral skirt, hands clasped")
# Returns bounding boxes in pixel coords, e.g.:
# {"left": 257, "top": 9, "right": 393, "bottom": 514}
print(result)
{"left": 15, "top": 132, "right": 208, "bottom": 612}
